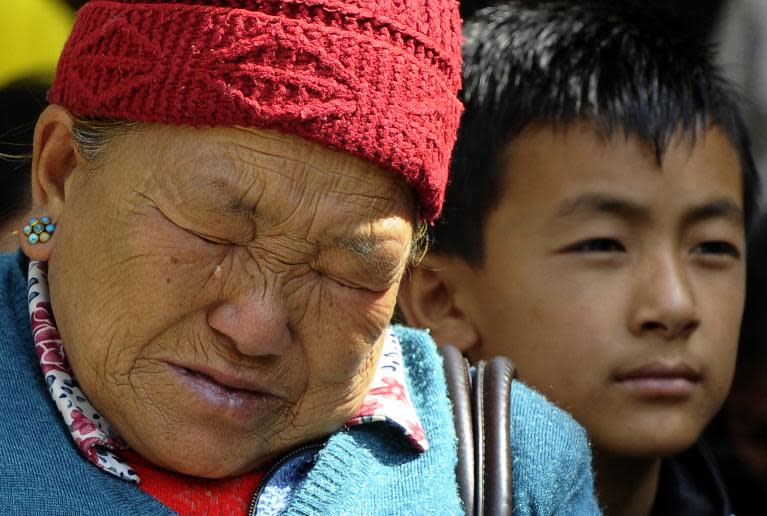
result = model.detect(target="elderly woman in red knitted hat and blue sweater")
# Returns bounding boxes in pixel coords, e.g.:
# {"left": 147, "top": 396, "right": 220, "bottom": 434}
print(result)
{"left": 0, "top": 0, "right": 597, "bottom": 515}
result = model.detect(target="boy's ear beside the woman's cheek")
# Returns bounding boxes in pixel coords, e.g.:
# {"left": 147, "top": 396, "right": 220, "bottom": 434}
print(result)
{"left": 397, "top": 254, "right": 479, "bottom": 352}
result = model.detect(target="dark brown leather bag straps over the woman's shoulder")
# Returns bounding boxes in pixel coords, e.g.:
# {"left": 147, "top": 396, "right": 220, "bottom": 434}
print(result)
{"left": 440, "top": 346, "right": 516, "bottom": 516}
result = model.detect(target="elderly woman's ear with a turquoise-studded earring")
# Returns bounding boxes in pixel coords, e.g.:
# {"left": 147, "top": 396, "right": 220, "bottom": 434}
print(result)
{"left": 19, "top": 104, "right": 78, "bottom": 261}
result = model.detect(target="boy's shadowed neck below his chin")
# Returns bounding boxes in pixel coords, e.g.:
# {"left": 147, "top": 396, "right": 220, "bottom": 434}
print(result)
{"left": 594, "top": 449, "right": 662, "bottom": 516}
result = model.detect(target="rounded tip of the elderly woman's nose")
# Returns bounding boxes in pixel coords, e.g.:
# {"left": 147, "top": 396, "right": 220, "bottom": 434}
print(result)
{"left": 208, "top": 296, "right": 291, "bottom": 357}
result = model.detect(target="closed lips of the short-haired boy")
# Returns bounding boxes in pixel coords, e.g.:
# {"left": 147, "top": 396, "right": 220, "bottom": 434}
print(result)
{"left": 616, "top": 362, "right": 702, "bottom": 398}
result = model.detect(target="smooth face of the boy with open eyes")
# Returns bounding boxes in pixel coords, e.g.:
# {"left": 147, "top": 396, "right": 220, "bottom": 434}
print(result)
{"left": 464, "top": 123, "right": 745, "bottom": 456}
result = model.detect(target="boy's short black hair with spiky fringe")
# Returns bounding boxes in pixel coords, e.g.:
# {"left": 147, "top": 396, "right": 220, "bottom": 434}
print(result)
{"left": 432, "top": 0, "right": 758, "bottom": 266}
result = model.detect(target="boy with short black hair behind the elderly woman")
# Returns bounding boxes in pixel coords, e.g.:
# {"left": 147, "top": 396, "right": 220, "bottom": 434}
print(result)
{"left": 400, "top": 2, "right": 757, "bottom": 516}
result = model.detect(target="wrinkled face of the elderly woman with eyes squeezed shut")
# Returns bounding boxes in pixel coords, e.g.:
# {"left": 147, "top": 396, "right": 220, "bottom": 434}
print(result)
{"left": 45, "top": 126, "right": 415, "bottom": 477}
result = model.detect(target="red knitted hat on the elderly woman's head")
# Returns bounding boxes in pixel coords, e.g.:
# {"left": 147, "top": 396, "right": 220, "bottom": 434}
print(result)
{"left": 49, "top": 0, "right": 468, "bottom": 220}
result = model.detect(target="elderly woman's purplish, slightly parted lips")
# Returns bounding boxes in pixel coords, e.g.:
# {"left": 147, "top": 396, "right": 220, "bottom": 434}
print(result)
{"left": 169, "top": 364, "right": 282, "bottom": 421}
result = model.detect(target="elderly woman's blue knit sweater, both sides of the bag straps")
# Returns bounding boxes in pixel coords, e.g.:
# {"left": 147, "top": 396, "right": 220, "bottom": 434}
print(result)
{"left": 0, "top": 255, "right": 599, "bottom": 516}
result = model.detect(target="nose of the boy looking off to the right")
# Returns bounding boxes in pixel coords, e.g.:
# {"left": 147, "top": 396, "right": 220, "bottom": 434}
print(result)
{"left": 630, "top": 259, "right": 700, "bottom": 340}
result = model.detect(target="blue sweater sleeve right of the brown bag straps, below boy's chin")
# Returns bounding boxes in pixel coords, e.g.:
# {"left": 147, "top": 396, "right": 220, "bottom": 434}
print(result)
{"left": 511, "top": 381, "right": 601, "bottom": 516}
